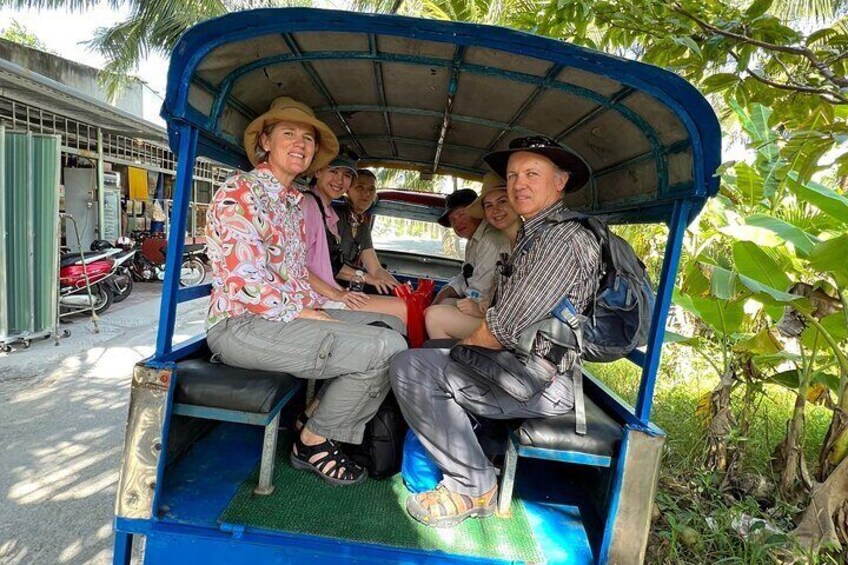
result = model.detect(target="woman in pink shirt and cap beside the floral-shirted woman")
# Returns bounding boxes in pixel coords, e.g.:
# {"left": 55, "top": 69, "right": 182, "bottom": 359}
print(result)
{"left": 301, "top": 150, "right": 407, "bottom": 326}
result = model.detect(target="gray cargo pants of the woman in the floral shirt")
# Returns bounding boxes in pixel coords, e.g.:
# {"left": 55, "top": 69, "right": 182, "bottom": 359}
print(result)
{"left": 206, "top": 310, "right": 406, "bottom": 443}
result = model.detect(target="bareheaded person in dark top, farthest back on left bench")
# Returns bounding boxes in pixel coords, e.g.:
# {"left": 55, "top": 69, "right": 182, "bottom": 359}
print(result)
{"left": 338, "top": 169, "right": 400, "bottom": 294}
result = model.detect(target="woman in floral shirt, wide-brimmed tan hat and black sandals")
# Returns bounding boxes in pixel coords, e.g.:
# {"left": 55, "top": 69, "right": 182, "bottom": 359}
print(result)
{"left": 206, "top": 97, "right": 406, "bottom": 485}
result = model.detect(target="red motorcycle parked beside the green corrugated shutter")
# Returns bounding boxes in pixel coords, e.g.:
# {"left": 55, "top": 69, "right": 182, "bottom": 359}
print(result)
{"left": 59, "top": 248, "right": 121, "bottom": 316}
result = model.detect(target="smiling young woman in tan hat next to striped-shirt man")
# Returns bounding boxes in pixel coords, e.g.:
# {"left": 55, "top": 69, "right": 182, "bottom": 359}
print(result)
{"left": 424, "top": 173, "right": 521, "bottom": 339}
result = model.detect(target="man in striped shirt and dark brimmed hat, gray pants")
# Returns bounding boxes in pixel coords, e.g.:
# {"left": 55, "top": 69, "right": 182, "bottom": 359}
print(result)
{"left": 390, "top": 137, "right": 601, "bottom": 526}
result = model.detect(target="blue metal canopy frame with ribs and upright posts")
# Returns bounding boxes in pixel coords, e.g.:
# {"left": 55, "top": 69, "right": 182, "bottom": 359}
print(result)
{"left": 156, "top": 9, "right": 721, "bottom": 425}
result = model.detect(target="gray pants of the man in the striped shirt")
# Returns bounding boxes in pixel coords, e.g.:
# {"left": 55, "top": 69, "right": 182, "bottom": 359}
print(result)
{"left": 390, "top": 349, "right": 580, "bottom": 496}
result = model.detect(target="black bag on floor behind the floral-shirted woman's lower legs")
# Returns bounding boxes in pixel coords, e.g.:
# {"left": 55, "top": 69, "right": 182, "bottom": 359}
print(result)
{"left": 345, "top": 392, "right": 407, "bottom": 479}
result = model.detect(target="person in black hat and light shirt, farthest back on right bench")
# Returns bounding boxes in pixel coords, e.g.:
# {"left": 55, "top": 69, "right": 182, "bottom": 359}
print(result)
{"left": 433, "top": 188, "right": 509, "bottom": 305}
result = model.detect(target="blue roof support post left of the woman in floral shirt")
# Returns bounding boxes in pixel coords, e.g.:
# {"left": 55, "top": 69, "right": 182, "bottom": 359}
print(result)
{"left": 156, "top": 124, "right": 197, "bottom": 358}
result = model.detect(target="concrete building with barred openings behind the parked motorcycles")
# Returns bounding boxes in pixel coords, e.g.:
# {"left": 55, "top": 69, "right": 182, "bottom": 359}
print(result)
{"left": 0, "top": 40, "right": 230, "bottom": 249}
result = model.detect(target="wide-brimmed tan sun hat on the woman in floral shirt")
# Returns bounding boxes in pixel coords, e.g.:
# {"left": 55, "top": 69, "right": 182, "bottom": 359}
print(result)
{"left": 244, "top": 96, "right": 339, "bottom": 174}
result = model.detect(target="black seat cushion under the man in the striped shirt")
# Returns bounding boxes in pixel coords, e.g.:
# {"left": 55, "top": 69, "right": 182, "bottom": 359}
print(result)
{"left": 515, "top": 397, "right": 622, "bottom": 456}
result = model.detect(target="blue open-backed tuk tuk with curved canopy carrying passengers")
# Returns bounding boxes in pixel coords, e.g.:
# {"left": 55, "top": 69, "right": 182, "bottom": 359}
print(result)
{"left": 114, "top": 8, "right": 720, "bottom": 565}
